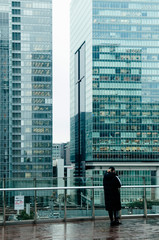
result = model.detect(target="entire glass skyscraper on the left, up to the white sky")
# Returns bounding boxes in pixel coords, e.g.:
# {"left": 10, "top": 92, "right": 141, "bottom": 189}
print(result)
{"left": 0, "top": 0, "right": 52, "bottom": 178}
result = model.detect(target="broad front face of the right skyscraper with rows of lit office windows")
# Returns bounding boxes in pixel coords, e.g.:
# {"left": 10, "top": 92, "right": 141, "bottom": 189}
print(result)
{"left": 92, "top": 1, "right": 159, "bottom": 162}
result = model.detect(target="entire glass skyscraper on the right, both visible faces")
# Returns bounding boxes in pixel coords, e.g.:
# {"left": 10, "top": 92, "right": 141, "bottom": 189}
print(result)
{"left": 70, "top": 0, "right": 159, "bottom": 186}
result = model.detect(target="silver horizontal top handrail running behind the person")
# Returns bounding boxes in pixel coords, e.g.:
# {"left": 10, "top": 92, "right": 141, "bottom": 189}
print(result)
{"left": 0, "top": 185, "right": 159, "bottom": 192}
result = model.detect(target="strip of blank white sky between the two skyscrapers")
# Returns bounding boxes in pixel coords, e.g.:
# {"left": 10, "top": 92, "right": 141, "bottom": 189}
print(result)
{"left": 53, "top": 0, "right": 71, "bottom": 143}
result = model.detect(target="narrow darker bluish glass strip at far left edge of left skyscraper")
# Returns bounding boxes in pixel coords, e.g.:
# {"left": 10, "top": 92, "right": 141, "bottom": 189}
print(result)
{"left": 0, "top": 4, "right": 10, "bottom": 179}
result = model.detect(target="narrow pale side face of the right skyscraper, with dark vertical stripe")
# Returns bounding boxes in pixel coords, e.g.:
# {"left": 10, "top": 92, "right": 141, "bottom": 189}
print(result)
{"left": 70, "top": 0, "right": 92, "bottom": 175}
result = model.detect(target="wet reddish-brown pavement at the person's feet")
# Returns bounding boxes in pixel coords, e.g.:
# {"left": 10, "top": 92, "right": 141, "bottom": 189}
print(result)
{"left": 0, "top": 218, "right": 159, "bottom": 240}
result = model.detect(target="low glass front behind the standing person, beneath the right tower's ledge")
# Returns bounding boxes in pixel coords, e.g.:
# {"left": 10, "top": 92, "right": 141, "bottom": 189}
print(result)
{"left": 86, "top": 168, "right": 153, "bottom": 205}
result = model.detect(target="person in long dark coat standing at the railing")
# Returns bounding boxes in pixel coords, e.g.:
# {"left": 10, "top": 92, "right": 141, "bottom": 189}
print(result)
{"left": 103, "top": 167, "right": 121, "bottom": 226}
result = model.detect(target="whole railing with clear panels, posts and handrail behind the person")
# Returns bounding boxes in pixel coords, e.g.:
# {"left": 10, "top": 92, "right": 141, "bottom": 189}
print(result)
{"left": 0, "top": 185, "right": 159, "bottom": 225}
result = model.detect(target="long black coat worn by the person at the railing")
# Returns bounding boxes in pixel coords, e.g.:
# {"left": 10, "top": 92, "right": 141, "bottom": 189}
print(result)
{"left": 103, "top": 172, "right": 121, "bottom": 211}
